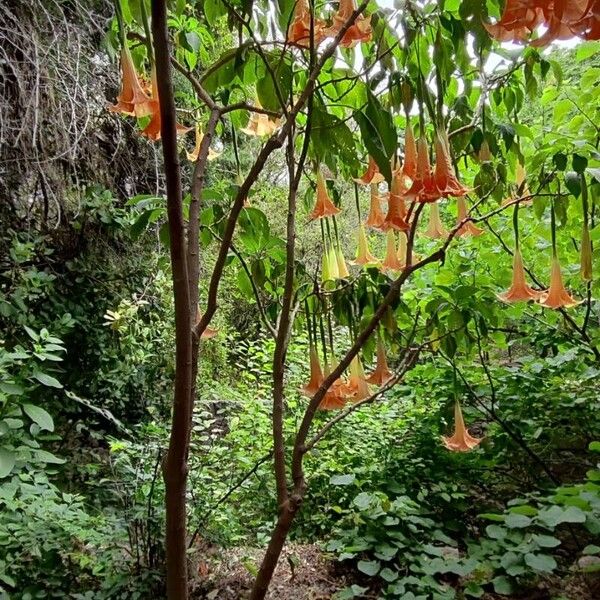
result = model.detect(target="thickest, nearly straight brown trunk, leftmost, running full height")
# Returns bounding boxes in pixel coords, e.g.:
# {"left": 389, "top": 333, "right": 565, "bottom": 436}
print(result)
{"left": 152, "top": 0, "right": 192, "bottom": 600}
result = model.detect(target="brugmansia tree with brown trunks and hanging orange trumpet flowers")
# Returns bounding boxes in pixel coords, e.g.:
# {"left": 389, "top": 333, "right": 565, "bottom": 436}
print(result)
{"left": 111, "top": 0, "right": 600, "bottom": 600}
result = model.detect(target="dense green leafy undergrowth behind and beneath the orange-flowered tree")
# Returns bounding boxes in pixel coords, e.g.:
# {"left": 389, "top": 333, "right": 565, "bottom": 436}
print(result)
{"left": 0, "top": 2, "right": 600, "bottom": 600}
